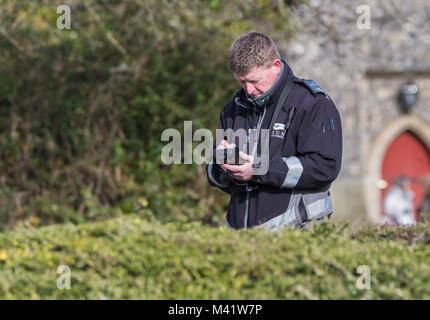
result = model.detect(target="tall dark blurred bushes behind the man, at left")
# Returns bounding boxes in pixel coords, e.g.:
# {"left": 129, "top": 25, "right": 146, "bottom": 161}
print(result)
{"left": 0, "top": 0, "right": 300, "bottom": 230}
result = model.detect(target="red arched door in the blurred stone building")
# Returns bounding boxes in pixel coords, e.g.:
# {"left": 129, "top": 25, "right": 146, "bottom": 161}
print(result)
{"left": 381, "top": 131, "right": 430, "bottom": 221}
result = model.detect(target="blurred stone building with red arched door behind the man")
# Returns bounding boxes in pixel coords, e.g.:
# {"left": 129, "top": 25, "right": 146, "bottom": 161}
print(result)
{"left": 279, "top": 0, "right": 430, "bottom": 225}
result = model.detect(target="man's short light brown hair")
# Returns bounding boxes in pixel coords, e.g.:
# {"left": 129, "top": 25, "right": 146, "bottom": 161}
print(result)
{"left": 228, "top": 32, "right": 281, "bottom": 75}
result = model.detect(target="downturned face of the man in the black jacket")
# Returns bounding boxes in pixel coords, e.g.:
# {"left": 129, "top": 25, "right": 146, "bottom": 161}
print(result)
{"left": 234, "top": 59, "right": 282, "bottom": 99}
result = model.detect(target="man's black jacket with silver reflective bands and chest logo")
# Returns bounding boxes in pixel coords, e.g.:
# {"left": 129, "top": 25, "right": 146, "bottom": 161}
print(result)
{"left": 206, "top": 61, "right": 342, "bottom": 231}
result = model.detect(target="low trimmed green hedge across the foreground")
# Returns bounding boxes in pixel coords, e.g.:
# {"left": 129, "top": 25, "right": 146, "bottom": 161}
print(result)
{"left": 0, "top": 215, "right": 430, "bottom": 299}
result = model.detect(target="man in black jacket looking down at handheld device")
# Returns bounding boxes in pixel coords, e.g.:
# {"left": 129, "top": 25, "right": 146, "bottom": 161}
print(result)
{"left": 206, "top": 32, "right": 342, "bottom": 231}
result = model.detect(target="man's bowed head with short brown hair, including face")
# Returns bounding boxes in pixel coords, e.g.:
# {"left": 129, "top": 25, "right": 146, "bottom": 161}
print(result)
{"left": 228, "top": 32, "right": 282, "bottom": 99}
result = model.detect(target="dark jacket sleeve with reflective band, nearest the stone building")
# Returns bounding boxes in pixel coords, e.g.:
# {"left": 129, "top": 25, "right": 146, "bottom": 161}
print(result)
{"left": 251, "top": 98, "right": 342, "bottom": 189}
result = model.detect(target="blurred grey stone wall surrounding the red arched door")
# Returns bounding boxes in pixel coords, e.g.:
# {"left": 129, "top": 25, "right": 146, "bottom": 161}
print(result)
{"left": 279, "top": 0, "right": 430, "bottom": 222}
